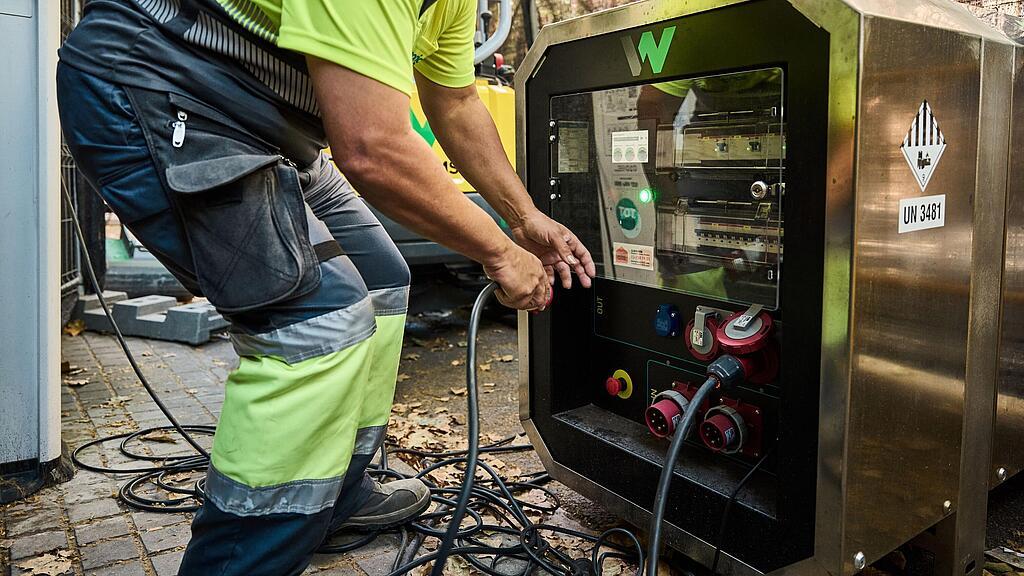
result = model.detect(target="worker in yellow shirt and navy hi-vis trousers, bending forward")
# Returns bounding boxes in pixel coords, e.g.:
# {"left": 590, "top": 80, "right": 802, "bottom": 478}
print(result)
{"left": 57, "top": 0, "right": 594, "bottom": 576}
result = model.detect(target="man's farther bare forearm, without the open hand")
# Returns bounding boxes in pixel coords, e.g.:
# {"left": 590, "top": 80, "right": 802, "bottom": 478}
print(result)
{"left": 419, "top": 75, "right": 537, "bottom": 228}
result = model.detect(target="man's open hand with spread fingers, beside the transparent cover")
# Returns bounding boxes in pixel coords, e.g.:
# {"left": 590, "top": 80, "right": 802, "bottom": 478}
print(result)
{"left": 511, "top": 210, "right": 595, "bottom": 288}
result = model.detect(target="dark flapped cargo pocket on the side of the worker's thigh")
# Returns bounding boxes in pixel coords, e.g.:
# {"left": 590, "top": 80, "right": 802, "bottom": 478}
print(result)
{"left": 164, "top": 154, "right": 321, "bottom": 313}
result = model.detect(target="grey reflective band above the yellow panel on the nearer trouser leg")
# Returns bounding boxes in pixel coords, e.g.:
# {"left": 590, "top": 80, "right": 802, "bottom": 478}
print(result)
{"left": 231, "top": 296, "right": 377, "bottom": 364}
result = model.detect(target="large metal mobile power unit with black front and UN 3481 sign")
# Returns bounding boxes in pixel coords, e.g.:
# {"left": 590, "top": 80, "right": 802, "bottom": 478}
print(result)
{"left": 516, "top": 0, "right": 1024, "bottom": 575}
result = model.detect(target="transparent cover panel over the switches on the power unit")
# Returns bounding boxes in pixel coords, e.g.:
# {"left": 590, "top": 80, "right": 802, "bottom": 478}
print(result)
{"left": 551, "top": 69, "right": 785, "bottom": 307}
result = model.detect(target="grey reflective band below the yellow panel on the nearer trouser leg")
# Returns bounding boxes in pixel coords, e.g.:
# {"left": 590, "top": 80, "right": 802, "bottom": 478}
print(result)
{"left": 206, "top": 465, "right": 342, "bottom": 517}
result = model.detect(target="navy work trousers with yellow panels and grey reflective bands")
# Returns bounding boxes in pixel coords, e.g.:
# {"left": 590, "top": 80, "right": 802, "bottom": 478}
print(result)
{"left": 57, "top": 65, "right": 410, "bottom": 576}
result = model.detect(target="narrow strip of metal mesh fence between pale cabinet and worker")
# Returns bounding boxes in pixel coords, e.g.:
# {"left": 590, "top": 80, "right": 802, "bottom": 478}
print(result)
{"left": 60, "top": 0, "right": 82, "bottom": 298}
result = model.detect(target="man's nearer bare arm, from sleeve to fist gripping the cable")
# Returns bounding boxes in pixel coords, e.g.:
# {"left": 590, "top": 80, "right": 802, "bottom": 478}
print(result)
{"left": 308, "top": 56, "right": 548, "bottom": 308}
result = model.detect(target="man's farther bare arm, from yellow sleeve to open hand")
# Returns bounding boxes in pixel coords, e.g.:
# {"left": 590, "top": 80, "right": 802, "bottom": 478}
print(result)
{"left": 416, "top": 72, "right": 594, "bottom": 288}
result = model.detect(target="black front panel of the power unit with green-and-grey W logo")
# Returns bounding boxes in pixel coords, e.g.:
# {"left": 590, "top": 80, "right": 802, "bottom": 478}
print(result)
{"left": 526, "top": 0, "right": 828, "bottom": 572}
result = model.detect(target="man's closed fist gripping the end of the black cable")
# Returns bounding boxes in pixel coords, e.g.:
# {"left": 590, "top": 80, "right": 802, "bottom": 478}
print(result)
{"left": 483, "top": 242, "right": 551, "bottom": 310}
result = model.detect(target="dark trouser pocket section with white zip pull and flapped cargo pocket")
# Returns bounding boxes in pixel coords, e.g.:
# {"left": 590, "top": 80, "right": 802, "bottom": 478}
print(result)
{"left": 129, "top": 89, "right": 321, "bottom": 313}
